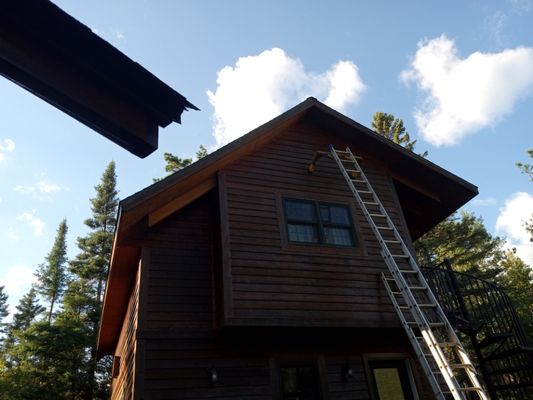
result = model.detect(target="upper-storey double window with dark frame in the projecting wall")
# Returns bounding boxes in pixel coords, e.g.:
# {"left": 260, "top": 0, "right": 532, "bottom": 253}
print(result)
{"left": 283, "top": 199, "right": 356, "bottom": 247}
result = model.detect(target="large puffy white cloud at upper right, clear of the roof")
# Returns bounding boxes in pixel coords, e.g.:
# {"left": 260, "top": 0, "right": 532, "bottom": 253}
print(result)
{"left": 400, "top": 35, "right": 533, "bottom": 146}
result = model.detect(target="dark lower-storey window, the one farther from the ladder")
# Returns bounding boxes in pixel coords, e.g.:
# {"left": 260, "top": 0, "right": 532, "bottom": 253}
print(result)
{"left": 280, "top": 365, "right": 320, "bottom": 400}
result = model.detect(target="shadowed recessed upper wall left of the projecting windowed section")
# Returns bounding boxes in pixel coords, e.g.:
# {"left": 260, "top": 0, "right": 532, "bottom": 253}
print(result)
{"left": 143, "top": 195, "right": 216, "bottom": 331}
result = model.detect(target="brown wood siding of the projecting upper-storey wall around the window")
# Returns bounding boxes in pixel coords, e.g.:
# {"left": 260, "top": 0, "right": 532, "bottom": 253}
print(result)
{"left": 219, "top": 124, "right": 409, "bottom": 327}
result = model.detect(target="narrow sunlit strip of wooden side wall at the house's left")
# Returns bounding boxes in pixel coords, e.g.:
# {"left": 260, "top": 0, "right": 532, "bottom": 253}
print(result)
{"left": 111, "top": 262, "right": 139, "bottom": 400}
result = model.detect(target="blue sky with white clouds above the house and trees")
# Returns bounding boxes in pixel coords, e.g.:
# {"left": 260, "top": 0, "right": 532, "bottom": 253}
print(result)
{"left": 0, "top": 0, "right": 533, "bottom": 312}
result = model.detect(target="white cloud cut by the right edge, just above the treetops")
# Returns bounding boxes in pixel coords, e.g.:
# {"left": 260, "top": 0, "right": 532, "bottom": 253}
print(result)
{"left": 496, "top": 192, "right": 533, "bottom": 267}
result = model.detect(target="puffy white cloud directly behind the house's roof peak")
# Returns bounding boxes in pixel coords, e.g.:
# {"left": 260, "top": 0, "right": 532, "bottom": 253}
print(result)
{"left": 207, "top": 48, "right": 365, "bottom": 146}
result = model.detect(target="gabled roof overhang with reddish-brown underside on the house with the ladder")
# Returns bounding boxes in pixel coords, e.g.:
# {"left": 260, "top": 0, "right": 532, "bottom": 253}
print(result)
{"left": 98, "top": 98, "right": 477, "bottom": 354}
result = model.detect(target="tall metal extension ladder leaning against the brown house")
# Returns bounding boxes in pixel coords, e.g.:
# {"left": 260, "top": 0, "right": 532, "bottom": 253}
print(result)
{"left": 329, "top": 145, "right": 488, "bottom": 400}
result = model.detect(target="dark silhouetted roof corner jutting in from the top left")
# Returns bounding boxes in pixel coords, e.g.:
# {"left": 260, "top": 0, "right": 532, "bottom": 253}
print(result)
{"left": 0, "top": 0, "right": 197, "bottom": 157}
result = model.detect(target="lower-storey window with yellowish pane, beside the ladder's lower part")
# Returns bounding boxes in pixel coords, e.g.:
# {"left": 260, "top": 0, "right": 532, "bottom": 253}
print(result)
{"left": 368, "top": 360, "right": 415, "bottom": 400}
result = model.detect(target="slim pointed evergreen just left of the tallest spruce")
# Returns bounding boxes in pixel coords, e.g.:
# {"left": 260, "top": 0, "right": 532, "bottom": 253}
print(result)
{"left": 35, "top": 219, "right": 68, "bottom": 322}
